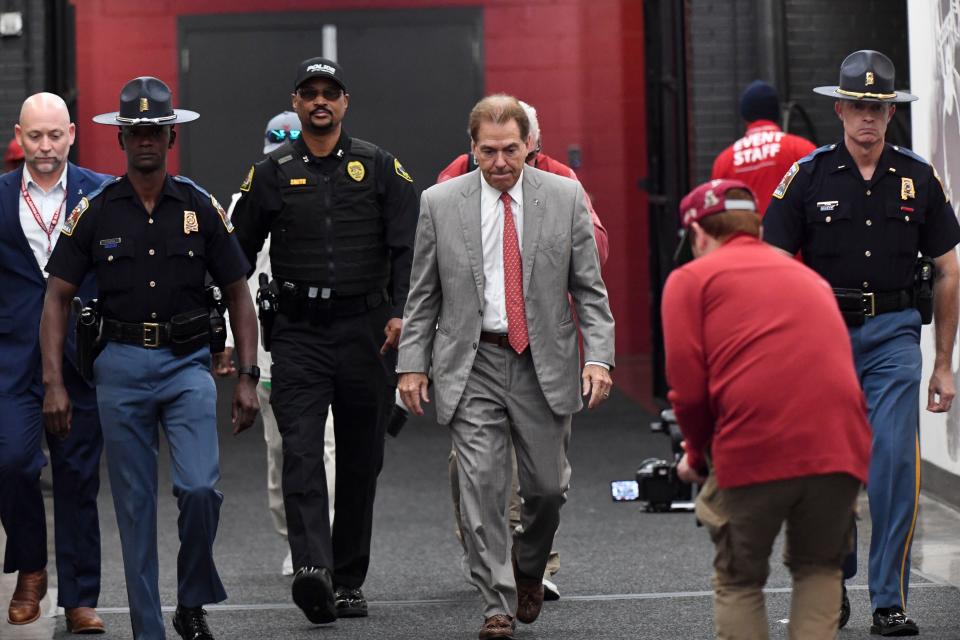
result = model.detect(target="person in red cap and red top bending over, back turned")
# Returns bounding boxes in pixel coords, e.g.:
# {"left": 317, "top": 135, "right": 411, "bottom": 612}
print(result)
{"left": 662, "top": 180, "right": 871, "bottom": 640}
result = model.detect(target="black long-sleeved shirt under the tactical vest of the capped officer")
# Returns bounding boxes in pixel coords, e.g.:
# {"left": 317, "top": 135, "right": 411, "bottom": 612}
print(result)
{"left": 232, "top": 132, "right": 419, "bottom": 318}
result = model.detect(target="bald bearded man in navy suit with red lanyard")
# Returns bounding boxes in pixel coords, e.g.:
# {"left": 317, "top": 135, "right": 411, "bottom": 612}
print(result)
{"left": 0, "top": 93, "right": 110, "bottom": 633}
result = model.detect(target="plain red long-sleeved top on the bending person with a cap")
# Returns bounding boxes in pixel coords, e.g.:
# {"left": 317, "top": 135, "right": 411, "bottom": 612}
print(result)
{"left": 661, "top": 235, "right": 871, "bottom": 488}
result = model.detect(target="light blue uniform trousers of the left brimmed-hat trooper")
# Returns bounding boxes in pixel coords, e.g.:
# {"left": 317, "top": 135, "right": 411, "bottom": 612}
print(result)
{"left": 94, "top": 342, "right": 227, "bottom": 640}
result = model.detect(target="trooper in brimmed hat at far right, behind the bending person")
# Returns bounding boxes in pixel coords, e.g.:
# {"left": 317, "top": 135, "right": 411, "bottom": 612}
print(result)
{"left": 763, "top": 50, "right": 960, "bottom": 636}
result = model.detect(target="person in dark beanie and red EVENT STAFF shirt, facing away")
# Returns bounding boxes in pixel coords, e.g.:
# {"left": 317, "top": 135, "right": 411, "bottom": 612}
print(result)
{"left": 710, "top": 80, "right": 816, "bottom": 212}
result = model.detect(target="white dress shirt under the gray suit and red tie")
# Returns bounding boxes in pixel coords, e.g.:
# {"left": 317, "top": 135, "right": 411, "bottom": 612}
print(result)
{"left": 478, "top": 171, "right": 523, "bottom": 333}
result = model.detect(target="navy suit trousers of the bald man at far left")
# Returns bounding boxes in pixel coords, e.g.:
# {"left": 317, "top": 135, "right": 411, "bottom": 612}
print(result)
{"left": 0, "top": 364, "right": 103, "bottom": 608}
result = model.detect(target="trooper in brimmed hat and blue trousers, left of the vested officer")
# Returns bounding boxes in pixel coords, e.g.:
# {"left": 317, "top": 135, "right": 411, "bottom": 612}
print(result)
{"left": 40, "top": 77, "right": 258, "bottom": 640}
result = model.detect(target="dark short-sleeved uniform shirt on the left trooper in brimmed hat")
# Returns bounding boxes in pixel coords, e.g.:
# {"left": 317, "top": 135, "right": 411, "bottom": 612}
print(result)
{"left": 47, "top": 176, "right": 250, "bottom": 322}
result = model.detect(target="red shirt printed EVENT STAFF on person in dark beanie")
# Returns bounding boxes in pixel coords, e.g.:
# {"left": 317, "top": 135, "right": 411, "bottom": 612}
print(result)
{"left": 710, "top": 120, "right": 816, "bottom": 216}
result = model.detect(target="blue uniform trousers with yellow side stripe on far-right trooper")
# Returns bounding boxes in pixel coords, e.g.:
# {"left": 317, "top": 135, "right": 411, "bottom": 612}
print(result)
{"left": 845, "top": 309, "right": 921, "bottom": 609}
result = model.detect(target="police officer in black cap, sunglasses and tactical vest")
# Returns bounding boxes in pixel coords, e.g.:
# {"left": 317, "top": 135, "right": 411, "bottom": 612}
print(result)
{"left": 233, "top": 58, "right": 417, "bottom": 624}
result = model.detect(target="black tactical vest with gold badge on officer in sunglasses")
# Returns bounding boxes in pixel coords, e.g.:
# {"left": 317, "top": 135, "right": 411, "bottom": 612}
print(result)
{"left": 269, "top": 138, "right": 390, "bottom": 296}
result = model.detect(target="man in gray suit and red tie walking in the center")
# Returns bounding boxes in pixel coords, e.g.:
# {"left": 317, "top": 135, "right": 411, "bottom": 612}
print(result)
{"left": 397, "top": 94, "right": 614, "bottom": 640}
